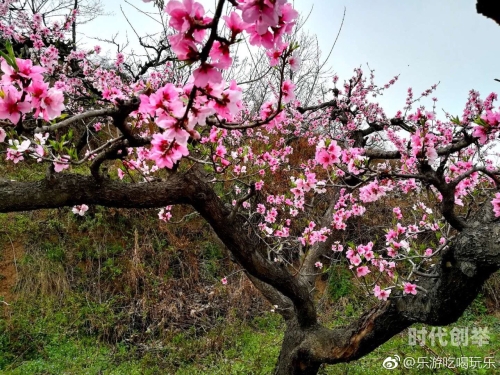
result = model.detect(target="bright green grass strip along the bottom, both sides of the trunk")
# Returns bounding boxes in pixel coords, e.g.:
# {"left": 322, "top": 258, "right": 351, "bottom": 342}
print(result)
{"left": 0, "top": 306, "right": 500, "bottom": 375}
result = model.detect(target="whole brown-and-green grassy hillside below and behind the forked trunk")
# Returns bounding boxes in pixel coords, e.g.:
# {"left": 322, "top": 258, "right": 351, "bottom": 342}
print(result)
{"left": 0, "top": 207, "right": 500, "bottom": 374}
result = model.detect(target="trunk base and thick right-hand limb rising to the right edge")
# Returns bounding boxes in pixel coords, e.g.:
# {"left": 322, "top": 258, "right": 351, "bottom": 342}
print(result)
{"left": 276, "top": 204, "right": 500, "bottom": 375}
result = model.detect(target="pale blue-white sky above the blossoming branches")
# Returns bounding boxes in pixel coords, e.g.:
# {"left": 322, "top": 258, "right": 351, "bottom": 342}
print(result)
{"left": 79, "top": 0, "right": 500, "bottom": 115}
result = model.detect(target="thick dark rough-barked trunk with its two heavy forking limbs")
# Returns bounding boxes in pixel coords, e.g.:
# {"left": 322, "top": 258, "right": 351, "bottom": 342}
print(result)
{"left": 0, "top": 170, "right": 500, "bottom": 375}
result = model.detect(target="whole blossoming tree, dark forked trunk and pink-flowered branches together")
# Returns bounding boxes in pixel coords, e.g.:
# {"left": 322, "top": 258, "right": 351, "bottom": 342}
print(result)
{"left": 0, "top": 0, "right": 500, "bottom": 374}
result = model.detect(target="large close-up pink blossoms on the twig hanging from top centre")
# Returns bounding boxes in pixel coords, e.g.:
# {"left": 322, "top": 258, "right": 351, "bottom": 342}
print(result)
{"left": 135, "top": 0, "right": 300, "bottom": 173}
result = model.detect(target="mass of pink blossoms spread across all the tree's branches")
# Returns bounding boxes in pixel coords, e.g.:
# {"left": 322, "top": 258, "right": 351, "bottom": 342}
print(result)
{"left": 0, "top": 0, "right": 500, "bottom": 306}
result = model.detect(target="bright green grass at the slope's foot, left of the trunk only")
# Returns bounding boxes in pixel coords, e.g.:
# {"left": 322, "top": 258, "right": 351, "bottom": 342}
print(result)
{"left": 0, "top": 314, "right": 282, "bottom": 375}
